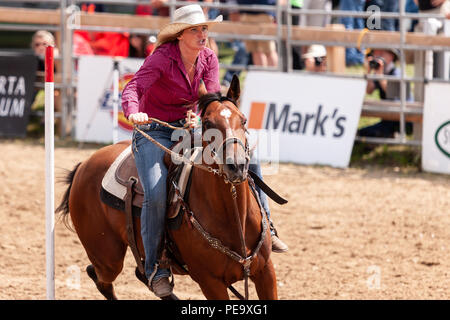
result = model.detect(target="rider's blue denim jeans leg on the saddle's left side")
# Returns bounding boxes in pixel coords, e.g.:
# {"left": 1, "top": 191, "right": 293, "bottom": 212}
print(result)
{"left": 133, "top": 130, "right": 173, "bottom": 280}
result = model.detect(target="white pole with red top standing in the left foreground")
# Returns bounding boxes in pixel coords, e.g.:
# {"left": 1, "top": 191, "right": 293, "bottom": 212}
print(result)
{"left": 45, "top": 46, "right": 55, "bottom": 300}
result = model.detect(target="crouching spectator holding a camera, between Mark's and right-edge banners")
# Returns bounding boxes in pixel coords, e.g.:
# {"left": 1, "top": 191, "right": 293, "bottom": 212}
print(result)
{"left": 358, "top": 49, "right": 412, "bottom": 138}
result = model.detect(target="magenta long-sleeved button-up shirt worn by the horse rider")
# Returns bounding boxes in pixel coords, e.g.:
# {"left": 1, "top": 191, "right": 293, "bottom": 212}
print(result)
{"left": 122, "top": 42, "right": 220, "bottom": 122}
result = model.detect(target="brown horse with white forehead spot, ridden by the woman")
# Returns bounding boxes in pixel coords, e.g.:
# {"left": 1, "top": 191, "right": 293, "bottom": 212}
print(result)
{"left": 57, "top": 77, "right": 277, "bottom": 299}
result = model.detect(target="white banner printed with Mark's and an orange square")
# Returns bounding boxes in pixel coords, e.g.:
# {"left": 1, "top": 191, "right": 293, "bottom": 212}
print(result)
{"left": 241, "top": 72, "right": 366, "bottom": 167}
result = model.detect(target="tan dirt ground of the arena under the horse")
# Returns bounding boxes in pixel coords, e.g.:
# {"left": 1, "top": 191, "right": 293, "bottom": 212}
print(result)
{"left": 0, "top": 141, "right": 450, "bottom": 300}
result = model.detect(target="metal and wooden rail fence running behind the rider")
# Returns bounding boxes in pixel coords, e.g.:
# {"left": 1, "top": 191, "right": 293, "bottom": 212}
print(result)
{"left": 0, "top": 0, "right": 450, "bottom": 145}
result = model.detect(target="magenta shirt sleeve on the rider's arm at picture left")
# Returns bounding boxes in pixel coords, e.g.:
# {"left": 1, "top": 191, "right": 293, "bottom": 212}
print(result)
{"left": 122, "top": 51, "right": 164, "bottom": 118}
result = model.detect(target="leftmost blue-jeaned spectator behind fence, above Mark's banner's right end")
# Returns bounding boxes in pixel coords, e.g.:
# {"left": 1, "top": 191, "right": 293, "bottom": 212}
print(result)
{"left": 339, "top": 0, "right": 365, "bottom": 66}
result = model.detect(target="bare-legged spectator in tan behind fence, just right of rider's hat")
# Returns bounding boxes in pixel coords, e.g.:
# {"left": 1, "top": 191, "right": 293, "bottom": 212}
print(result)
{"left": 237, "top": 0, "right": 278, "bottom": 67}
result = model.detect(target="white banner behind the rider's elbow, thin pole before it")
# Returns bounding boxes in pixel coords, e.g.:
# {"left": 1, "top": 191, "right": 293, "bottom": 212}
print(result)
{"left": 76, "top": 56, "right": 144, "bottom": 143}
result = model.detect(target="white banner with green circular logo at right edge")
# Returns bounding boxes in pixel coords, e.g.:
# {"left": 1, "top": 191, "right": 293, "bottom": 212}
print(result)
{"left": 422, "top": 83, "right": 450, "bottom": 174}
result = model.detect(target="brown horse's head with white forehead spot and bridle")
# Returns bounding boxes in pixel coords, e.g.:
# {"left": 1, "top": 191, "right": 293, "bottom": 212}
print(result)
{"left": 199, "top": 76, "right": 250, "bottom": 184}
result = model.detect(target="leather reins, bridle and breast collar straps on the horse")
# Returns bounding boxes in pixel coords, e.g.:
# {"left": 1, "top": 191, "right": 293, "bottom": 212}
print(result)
{"left": 134, "top": 119, "right": 267, "bottom": 300}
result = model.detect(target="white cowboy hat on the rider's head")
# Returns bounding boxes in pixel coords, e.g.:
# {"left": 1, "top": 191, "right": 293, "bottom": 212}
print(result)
{"left": 155, "top": 4, "right": 223, "bottom": 48}
